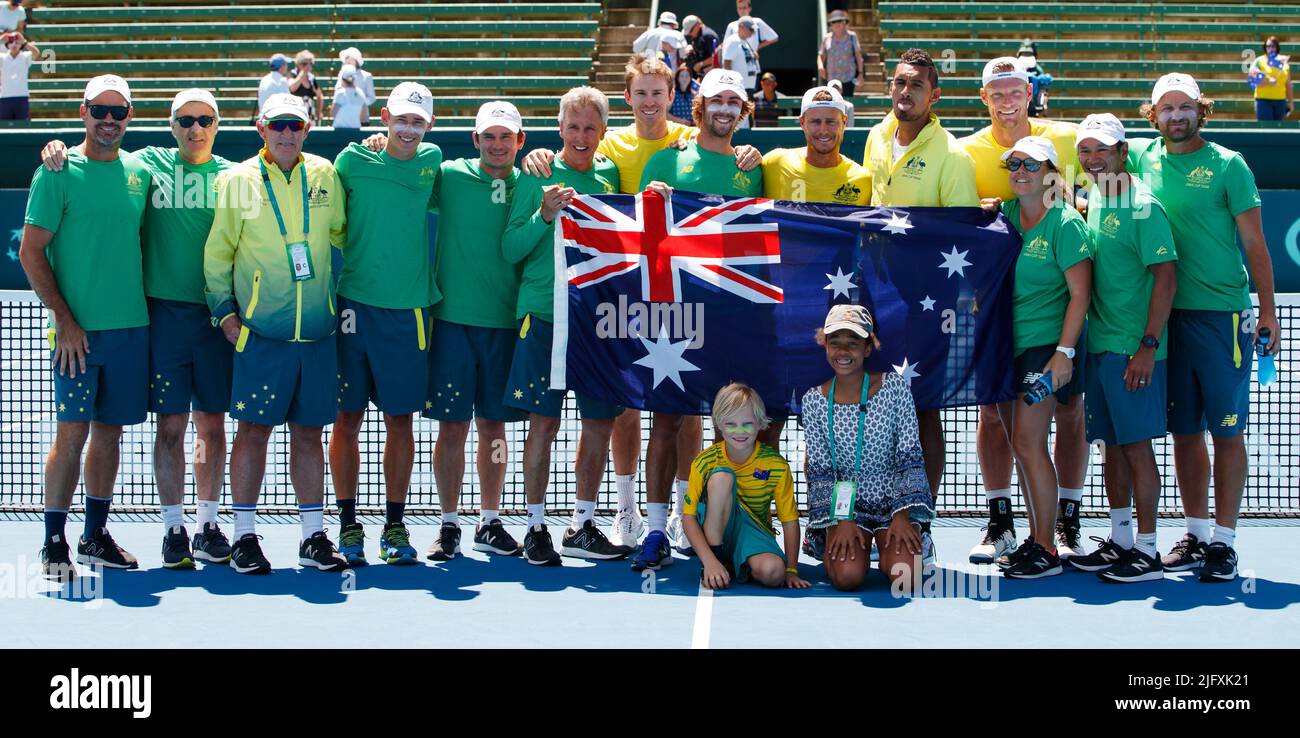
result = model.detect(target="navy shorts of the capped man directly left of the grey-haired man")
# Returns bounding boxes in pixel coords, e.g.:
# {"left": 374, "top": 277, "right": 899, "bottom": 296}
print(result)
{"left": 420, "top": 321, "right": 528, "bottom": 422}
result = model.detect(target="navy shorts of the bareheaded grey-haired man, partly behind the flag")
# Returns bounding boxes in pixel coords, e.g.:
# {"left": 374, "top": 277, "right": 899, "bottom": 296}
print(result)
{"left": 502, "top": 314, "right": 623, "bottom": 420}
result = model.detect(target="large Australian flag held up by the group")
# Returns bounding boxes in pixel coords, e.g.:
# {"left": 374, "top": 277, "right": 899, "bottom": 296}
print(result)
{"left": 551, "top": 191, "right": 1021, "bottom": 414}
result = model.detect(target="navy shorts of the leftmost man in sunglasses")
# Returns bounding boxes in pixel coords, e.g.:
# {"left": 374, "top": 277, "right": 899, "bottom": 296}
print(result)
{"left": 49, "top": 325, "right": 150, "bottom": 425}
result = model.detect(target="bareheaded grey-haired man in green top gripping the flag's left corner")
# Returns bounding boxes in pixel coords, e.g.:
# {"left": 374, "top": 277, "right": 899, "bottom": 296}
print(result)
{"left": 502, "top": 87, "right": 632, "bottom": 566}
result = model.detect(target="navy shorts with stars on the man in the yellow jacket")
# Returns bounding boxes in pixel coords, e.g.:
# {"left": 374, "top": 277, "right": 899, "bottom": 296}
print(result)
{"left": 230, "top": 326, "right": 338, "bottom": 426}
